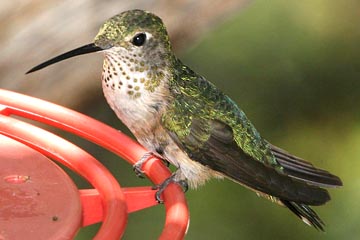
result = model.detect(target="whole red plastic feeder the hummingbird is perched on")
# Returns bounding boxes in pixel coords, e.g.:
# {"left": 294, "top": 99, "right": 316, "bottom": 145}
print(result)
{"left": 0, "top": 89, "right": 189, "bottom": 240}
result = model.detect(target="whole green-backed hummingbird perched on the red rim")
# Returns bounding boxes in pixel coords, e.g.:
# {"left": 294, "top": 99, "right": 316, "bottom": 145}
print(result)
{"left": 27, "top": 9, "right": 342, "bottom": 230}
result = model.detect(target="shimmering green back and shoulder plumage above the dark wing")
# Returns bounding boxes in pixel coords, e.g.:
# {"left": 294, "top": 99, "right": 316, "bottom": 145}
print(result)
{"left": 163, "top": 60, "right": 281, "bottom": 168}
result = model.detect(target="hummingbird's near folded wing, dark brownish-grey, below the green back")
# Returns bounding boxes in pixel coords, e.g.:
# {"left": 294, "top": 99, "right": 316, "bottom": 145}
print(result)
{"left": 163, "top": 119, "right": 330, "bottom": 205}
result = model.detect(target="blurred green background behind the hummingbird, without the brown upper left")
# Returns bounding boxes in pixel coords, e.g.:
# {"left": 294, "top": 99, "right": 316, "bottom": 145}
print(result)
{"left": 2, "top": 0, "right": 360, "bottom": 240}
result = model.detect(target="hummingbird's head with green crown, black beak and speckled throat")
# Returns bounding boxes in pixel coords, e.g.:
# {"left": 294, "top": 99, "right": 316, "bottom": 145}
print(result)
{"left": 27, "top": 10, "right": 174, "bottom": 93}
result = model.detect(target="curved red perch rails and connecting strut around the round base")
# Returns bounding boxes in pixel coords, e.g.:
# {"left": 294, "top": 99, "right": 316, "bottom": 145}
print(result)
{"left": 0, "top": 89, "right": 189, "bottom": 239}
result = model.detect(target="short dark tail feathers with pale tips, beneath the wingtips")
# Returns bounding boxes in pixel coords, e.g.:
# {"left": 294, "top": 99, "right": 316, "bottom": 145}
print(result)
{"left": 280, "top": 200, "right": 325, "bottom": 232}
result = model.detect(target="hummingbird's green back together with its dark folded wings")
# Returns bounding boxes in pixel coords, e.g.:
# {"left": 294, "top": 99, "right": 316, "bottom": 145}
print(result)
{"left": 162, "top": 66, "right": 341, "bottom": 205}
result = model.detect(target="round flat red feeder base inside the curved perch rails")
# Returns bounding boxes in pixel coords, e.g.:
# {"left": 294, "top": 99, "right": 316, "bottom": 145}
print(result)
{"left": 0, "top": 135, "right": 82, "bottom": 240}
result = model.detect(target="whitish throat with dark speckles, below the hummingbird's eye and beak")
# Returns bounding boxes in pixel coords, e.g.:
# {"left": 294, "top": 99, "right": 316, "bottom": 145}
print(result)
{"left": 102, "top": 35, "right": 173, "bottom": 94}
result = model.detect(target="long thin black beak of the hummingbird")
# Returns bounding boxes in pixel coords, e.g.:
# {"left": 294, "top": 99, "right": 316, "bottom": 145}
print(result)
{"left": 26, "top": 43, "right": 104, "bottom": 74}
